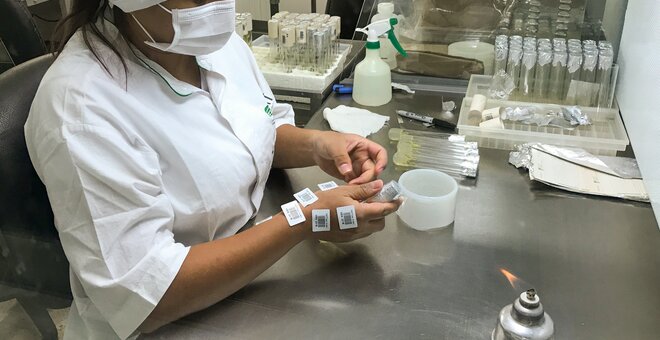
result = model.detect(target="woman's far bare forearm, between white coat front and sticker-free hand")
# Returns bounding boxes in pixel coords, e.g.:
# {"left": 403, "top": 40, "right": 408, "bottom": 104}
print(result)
{"left": 273, "top": 125, "right": 320, "bottom": 169}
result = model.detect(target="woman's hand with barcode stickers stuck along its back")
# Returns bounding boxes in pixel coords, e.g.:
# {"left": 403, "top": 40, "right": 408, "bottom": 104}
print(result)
{"left": 303, "top": 180, "right": 401, "bottom": 242}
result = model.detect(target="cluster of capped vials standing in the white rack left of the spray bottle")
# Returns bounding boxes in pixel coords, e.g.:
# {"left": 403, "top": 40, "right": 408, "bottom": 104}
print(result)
{"left": 268, "top": 12, "right": 341, "bottom": 74}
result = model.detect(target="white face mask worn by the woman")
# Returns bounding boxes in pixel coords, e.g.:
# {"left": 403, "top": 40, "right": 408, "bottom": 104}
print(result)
{"left": 131, "top": 0, "right": 236, "bottom": 56}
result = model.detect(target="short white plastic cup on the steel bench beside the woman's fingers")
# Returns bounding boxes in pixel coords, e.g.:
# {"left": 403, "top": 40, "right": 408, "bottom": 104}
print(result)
{"left": 397, "top": 169, "right": 458, "bottom": 230}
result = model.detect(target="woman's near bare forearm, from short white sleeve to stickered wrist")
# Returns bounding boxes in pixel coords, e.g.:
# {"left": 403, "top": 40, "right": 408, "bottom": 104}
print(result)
{"left": 140, "top": 213, "right": 306, "bottom": 333}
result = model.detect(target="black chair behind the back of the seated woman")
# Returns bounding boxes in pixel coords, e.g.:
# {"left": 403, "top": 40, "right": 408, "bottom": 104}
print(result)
{"left": 0, "top": 55, "right": 71, "bottom": 338}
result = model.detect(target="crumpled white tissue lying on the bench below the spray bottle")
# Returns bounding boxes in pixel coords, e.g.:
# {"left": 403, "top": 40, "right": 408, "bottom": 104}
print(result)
{"left": 323, "top": 105, "right": 390, "bottom": 137}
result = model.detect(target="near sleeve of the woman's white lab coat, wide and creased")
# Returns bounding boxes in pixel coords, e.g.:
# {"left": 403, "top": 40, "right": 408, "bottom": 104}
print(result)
{"left": 28, "top": 124, "right": 189, "bottom": 339}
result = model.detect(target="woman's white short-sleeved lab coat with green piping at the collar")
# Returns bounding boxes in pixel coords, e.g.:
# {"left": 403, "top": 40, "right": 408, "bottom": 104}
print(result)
{"left": 25, "top": 22, "right": 293, "bottom": 339}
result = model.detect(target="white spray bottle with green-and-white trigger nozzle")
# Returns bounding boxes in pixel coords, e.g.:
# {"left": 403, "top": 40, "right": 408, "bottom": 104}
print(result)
{"left": 353, "top": 18, "right": 408, "bottom": 106}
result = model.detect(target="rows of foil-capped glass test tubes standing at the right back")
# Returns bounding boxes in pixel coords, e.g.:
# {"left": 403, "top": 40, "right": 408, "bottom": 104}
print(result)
{"left": 495, "top": 35, "right": 614, "bottom": 108}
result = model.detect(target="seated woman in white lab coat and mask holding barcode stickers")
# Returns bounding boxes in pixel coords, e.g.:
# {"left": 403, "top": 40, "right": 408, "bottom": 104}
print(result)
{"left": 25, "top": 0, "right": 398, "bottom": 339}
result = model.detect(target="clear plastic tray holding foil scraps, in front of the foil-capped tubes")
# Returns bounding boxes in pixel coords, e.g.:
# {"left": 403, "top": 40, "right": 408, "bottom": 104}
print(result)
{"left": 458, "top": 96, "right": 629, "bottom": 156}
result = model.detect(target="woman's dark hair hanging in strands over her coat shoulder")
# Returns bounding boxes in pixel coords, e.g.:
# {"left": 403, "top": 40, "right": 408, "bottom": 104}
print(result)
{"left": 52, "top": 0, "right": 127, "bottom": 73}
